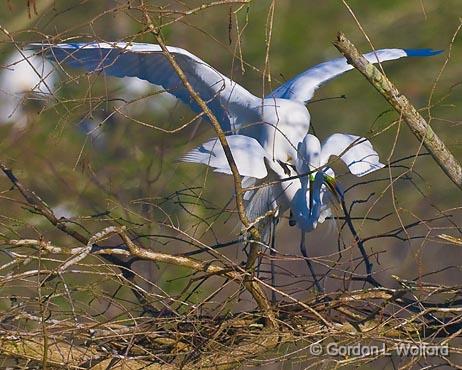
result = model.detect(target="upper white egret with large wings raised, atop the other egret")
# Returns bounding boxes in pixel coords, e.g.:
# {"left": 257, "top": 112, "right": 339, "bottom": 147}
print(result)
{"left": 29, "top": 42, "right": 440, "bottom": 164}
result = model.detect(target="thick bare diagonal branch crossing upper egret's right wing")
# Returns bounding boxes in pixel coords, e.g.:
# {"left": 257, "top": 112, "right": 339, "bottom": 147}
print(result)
{"left": 334, "top": 32, "right": 462, "bottom": 189}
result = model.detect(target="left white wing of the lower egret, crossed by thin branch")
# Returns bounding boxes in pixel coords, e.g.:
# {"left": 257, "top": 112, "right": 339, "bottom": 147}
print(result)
{"left": 181, "top": 135, "right": 268, "bottom": 179}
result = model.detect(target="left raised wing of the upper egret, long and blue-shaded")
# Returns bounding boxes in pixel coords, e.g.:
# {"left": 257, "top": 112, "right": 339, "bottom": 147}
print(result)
{"left": 28, "top": 42, "right": 258, "bottom": 131}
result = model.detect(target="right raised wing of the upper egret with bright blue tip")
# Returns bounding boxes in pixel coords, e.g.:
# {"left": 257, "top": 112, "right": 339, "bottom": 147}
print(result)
{"left": 267, "top": 49, "right": 442, "bottom": 102}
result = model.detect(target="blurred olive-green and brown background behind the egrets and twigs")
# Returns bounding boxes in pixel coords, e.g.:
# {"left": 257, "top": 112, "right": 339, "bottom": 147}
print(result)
{"left": 0, "top": 0, "right": 462, "bottom": 316}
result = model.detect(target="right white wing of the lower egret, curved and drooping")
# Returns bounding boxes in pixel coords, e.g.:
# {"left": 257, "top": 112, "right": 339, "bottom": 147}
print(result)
{"left": 321, "top": 134, "right": 384, "bottom": 177}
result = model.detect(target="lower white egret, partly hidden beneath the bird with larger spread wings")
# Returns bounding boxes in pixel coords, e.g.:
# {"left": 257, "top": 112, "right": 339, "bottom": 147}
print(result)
{"left": 181, "top": 134, "right": 383, "bottom": 291}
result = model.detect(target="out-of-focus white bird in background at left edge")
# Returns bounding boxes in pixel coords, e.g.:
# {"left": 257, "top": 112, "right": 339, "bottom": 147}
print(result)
{"left": 0, "top": 50, "right": 59, "bottom": 128}
